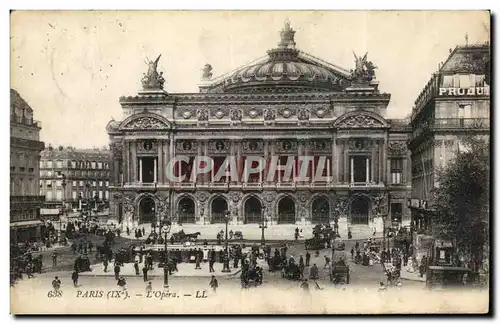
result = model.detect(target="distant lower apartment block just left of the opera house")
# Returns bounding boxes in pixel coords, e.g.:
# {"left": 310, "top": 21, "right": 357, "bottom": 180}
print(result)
{"left": 39, "top": 146, "right": 110, "bottom": 211}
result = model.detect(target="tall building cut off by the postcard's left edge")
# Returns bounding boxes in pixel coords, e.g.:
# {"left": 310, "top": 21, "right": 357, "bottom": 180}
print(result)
{"left": 10, "top": 89, "right": 44, "bottom": 242}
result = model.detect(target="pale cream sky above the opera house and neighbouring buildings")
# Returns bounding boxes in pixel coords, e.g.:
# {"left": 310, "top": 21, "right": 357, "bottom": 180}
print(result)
{"left": 10, "top": 11, "right": 490, "bottom": 148}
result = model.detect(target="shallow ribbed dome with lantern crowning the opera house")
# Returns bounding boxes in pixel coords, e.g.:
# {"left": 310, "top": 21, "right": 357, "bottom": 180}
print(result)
{"left": 200, "top": 22, "right": 349, "bottom": 92}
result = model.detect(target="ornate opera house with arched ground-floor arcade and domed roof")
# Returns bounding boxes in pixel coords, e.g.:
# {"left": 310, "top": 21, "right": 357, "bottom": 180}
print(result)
{"left": 107, "top": 23, "right": 411, "bottom": 233}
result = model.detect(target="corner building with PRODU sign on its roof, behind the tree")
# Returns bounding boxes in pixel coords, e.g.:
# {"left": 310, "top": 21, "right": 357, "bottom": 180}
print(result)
{"left": 408, "top": 44, "right": 490, "bottom": 232}
